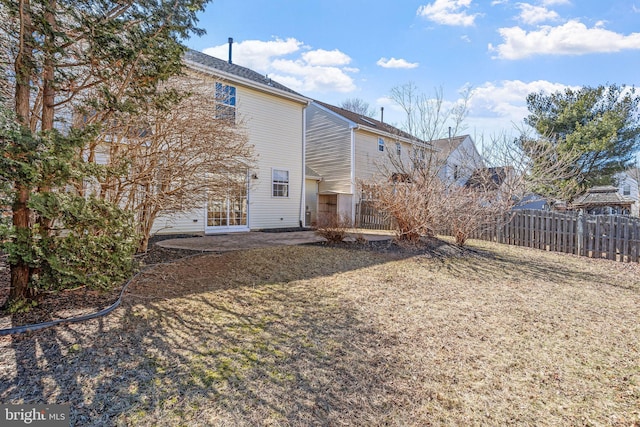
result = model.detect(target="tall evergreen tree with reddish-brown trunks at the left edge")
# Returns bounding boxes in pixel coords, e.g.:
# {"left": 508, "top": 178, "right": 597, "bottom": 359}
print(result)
{"left": 0, "top": 0, "right": 208, "bottom": 308}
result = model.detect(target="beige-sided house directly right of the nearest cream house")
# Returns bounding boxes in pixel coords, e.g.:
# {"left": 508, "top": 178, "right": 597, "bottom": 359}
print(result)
{"left": 305, "top": 101, "right": 431, "bottom": 221}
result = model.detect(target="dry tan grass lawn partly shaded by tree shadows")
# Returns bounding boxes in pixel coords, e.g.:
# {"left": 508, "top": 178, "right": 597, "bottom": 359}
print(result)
{"left": 0, "top": 242, "right": 640, "bottom": 426}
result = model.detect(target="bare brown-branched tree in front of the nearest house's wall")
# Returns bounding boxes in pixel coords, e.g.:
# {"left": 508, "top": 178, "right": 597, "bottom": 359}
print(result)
{"left": 87, "top": 72, "right": 253, "bottom": 252}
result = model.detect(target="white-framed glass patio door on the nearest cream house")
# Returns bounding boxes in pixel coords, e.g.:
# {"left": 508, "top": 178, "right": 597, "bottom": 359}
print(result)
{"left": 205, "top": 170, "right": 249, "bottom": 234}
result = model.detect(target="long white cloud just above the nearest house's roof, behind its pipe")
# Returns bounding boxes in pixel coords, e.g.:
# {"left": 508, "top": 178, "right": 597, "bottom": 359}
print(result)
{"left": 203, "top": 38, "right": 359, "bottom": 93}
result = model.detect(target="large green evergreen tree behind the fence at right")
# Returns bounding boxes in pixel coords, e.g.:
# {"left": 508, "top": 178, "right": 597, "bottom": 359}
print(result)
{"left": 521, "top": 85, "right": 640, "bottom": 199}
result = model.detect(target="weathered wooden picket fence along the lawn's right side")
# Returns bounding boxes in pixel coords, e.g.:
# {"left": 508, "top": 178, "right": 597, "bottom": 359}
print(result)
{"left": 470, "top": 210, "right": 640, "bottom": 262}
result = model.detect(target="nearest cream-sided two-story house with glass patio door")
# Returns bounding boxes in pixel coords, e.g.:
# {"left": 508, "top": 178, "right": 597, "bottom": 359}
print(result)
{"left": 153, "top": 50, "right": 310, "bottom": 234}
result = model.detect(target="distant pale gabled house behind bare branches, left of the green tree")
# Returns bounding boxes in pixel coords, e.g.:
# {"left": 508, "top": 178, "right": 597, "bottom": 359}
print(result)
{"left": 431, "top": 135, "right": 486, "bottom": 185}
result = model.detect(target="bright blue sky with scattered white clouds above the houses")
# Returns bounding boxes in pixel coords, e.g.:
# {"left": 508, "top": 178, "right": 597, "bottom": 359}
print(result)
{"left": 187, "top": 0, "right": 640, "bottom": 138}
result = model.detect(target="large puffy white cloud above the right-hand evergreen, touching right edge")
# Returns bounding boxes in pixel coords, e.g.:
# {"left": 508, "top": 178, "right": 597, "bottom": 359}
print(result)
{"left": 489, "top": 20, "right": 640, "bottom": 59}
